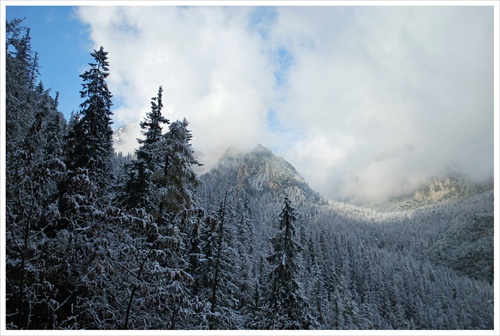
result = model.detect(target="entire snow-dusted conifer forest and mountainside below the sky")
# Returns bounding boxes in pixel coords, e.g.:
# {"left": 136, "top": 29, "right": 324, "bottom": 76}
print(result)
{"left": 2, "top": 20, "right": 494, "bottom": 330}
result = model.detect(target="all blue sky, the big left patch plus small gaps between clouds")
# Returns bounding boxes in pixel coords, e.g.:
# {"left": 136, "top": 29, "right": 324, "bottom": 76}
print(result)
{"left": 6, "top": 6, "right": 293, "bottom": 126}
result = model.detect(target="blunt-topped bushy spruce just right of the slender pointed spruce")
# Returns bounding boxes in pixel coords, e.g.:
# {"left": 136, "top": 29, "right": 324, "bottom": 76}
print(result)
{"left": 151, "top": 119, "right": 200, "bottom": 329}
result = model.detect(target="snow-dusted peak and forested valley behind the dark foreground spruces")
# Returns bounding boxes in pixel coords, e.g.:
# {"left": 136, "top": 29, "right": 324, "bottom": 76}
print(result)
{"left": 196, "top": 145, "right": 494, "bottom": 329}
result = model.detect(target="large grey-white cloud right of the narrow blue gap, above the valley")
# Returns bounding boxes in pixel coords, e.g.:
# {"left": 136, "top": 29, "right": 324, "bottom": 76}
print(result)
{"left": 268, "top": 7, "right": 493, "bottom": 200}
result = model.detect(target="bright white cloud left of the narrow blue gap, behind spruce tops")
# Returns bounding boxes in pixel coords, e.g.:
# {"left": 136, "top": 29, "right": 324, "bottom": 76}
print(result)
{"left": 80, "top": 7, "right": 274, "bottom": 153}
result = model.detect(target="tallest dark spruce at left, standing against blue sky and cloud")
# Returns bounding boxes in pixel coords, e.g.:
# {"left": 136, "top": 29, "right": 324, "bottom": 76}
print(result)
{"left": 59, "top": 47, "right": 113, "bottom": 228}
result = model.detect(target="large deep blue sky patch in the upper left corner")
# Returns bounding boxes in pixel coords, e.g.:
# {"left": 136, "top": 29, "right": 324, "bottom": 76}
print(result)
{"left": 6, "top": 6, "right": 92, "bottom": 118}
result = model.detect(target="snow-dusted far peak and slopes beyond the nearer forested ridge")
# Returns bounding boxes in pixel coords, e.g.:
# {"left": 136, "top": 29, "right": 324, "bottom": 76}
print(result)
{"left": 201, "top": 145, "right": 494, "bottom": 283}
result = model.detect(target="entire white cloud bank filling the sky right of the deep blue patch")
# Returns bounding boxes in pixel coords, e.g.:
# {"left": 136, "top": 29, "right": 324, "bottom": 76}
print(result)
{"left": 79, "top": 7, "right": 494, "bottom": 200}
